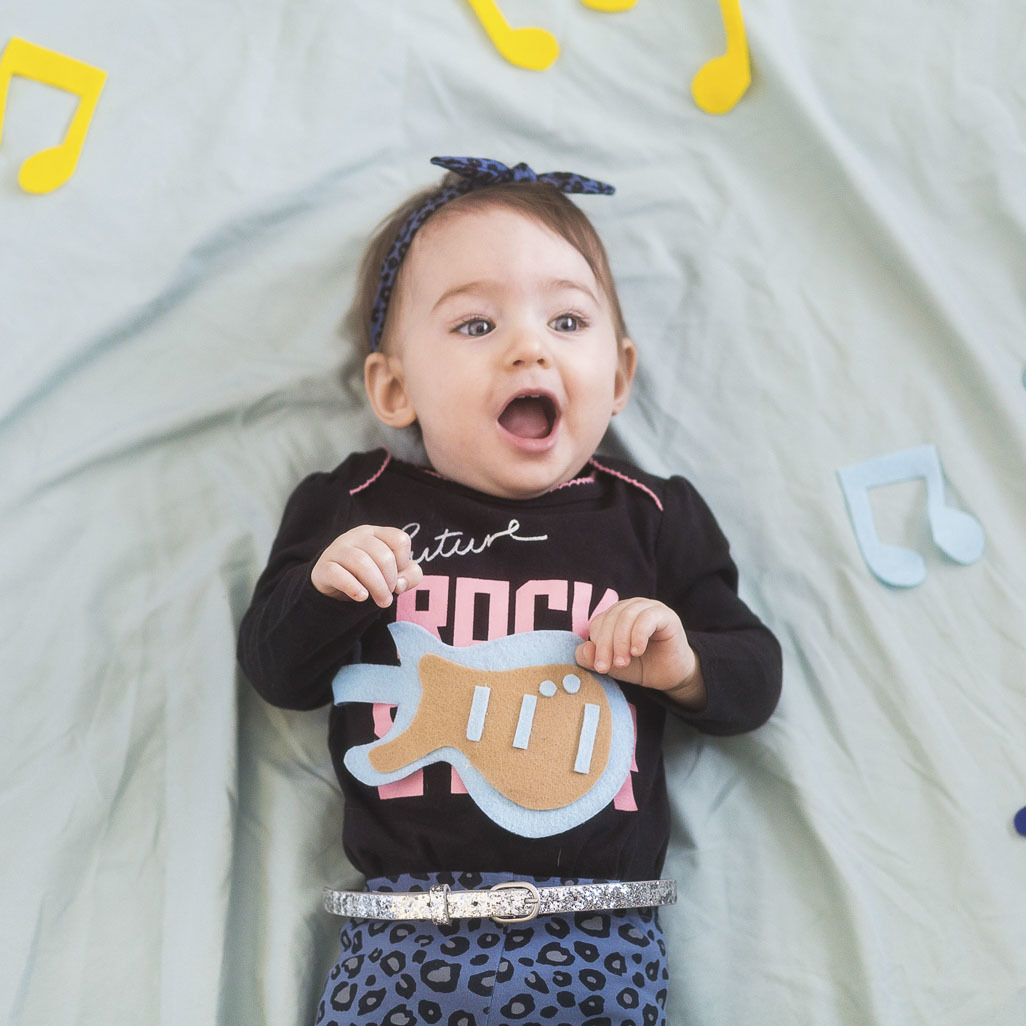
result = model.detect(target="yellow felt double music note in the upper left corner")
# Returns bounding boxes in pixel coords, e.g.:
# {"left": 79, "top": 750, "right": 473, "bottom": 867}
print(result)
{"left": 0, "top": 38, "right": 107, "bottom": 193}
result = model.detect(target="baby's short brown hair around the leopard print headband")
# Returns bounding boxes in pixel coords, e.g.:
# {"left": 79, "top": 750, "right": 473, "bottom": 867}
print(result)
{"left": 350, "top": 171, "right": 628, "bottom": 356}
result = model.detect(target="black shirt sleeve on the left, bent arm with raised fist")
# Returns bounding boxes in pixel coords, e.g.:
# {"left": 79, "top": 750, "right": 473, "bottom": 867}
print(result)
{"left": 238, "top": 464, "right": 381, "bottom": 709}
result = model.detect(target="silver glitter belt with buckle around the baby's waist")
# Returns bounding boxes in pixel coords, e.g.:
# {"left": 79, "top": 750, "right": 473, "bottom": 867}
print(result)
{"left": 324, "top": 880, "right": 677, "bottom": 926}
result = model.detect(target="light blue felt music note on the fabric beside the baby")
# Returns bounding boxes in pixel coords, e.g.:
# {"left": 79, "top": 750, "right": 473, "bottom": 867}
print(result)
{"left": 837, "top": 445, "right": 984, "bottom": 588}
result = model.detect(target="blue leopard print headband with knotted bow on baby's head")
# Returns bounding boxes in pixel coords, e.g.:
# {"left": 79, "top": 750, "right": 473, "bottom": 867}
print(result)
{"left": 370, "top": 157, "right": 616, "bottom": 352}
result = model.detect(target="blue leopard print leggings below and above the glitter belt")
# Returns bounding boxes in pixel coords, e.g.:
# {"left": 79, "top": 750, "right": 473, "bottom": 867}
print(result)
{"left": 315, "top": 873, "right": 669, "bottom": 1026}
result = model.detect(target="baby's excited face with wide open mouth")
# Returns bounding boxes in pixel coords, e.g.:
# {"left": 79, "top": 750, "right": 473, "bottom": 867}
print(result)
{"left": 379, "top": 206, "right": 634, "bottom": 499}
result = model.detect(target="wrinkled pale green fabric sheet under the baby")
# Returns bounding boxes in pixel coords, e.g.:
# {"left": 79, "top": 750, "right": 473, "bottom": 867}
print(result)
{"left": 0, "top": 0, "right": 1026, "bottom": 1026}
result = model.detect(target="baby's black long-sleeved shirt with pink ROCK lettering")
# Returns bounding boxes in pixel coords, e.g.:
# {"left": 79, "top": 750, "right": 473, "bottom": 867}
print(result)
{"left": 239, "top": 450, "right": 781, "bottom": 879}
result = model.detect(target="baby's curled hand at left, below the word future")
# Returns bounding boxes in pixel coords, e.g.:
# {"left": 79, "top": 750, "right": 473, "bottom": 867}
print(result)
{"left": 310, "top": 524, "right": 424, "bottom": 609}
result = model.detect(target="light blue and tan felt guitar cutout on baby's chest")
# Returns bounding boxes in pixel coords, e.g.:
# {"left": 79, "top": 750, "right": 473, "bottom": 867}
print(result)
{"left": 332, "top": 623, "right": 634, "bottom": 837}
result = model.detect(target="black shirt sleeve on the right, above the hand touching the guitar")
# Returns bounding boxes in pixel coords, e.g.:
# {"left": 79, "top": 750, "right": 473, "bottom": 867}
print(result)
{"left": 657, "top": 477, "right": 782, "bottom": 735}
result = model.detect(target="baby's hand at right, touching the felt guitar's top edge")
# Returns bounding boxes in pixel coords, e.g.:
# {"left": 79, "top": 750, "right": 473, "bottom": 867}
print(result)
{"left": 577, "top": 598, "right": 706, "bottom": 707}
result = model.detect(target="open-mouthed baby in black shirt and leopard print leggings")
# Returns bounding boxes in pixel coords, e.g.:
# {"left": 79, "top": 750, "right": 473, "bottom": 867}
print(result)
{"left": 239, "top": 158, "right": 781, "bottom": 1026}
